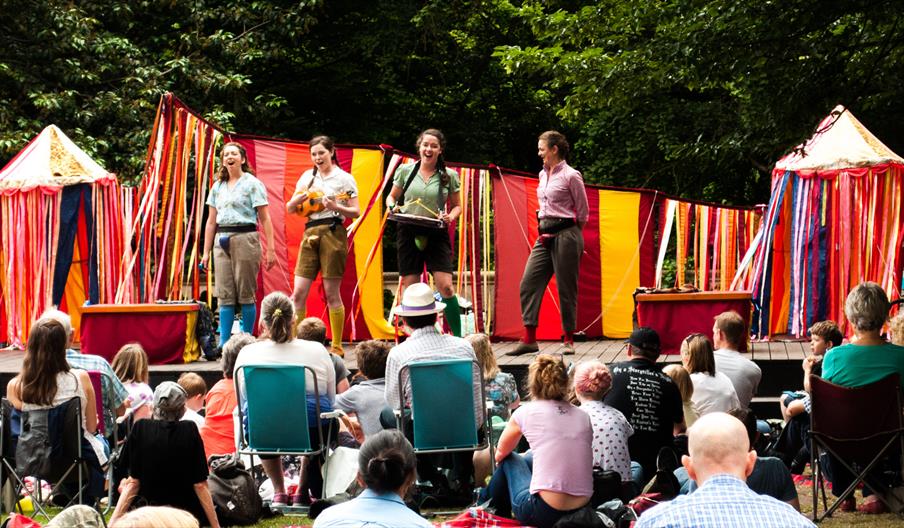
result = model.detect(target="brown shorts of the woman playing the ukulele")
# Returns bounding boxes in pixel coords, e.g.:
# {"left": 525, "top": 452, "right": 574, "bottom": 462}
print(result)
{"left": 295, "top": 224, "right": 348, "bottom": 280}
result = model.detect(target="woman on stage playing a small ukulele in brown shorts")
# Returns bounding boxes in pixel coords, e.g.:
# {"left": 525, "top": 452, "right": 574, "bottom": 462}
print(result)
{"left": 286, "top": 136, "right": 361, "bottom": 356}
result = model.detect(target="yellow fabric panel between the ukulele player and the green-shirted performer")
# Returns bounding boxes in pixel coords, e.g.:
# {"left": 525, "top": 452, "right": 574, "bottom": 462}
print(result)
{"left": 352, "top": 149, "right": 395, "bottom": 339}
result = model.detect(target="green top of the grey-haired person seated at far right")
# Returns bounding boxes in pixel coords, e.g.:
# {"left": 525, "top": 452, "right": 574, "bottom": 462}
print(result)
{"left": 822, "top": 343, "right": 904, "bottom": 387}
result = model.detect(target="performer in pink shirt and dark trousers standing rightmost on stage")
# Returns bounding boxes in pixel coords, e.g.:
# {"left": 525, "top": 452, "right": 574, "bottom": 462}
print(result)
{"left": 510, "top": 130, "right": 589, "bottom": 355}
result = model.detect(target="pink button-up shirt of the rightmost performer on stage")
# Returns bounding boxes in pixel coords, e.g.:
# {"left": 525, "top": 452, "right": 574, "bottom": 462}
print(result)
{"left": 537, "top": 161, "right": 590, "bottom": 223}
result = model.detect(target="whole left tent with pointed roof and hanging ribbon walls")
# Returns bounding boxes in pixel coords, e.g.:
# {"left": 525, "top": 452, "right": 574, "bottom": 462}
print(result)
{"left": 0, "top": 125, "right": 119, "bottom": 346}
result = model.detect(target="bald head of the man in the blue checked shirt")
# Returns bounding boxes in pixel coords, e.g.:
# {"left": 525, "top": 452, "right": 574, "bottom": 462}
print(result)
{"left": 682, "top": 413, "right": 756, "bottom": 485}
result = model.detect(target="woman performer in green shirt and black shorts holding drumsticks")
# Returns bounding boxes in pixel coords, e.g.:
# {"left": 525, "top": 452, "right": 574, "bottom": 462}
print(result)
{"left": 386, "top": 128, "right": 461, "bottom": 337}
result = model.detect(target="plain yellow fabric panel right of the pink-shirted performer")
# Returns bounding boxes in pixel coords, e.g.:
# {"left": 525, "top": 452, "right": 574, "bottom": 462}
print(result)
{"left": 599, "top": 190, "right": 640, "bottom": 338}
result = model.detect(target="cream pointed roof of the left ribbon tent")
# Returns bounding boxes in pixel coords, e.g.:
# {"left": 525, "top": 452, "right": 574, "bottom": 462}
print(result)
{"left": 0, "top": 125, "right": 116, "bottom": 193}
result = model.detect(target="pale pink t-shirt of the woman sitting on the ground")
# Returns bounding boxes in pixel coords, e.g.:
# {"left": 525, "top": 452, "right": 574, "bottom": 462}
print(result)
{"left": 512, "top": 400, "right": 593, "bottom": 497}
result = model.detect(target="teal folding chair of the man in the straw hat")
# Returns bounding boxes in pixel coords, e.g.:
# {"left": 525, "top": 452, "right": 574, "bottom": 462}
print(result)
{"left": 399, "top": 359, "right": 491, "bottom": 453}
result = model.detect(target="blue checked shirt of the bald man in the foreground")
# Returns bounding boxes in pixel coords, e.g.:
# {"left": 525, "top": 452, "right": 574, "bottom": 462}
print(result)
{"left": 635, "top": 474, "right": 816, "bottom": 528}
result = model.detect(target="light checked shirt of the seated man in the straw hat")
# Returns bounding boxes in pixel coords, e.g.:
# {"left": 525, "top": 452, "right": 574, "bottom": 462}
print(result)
{"left": 386, "top": 326, "right": 486, "bottom": 427}
